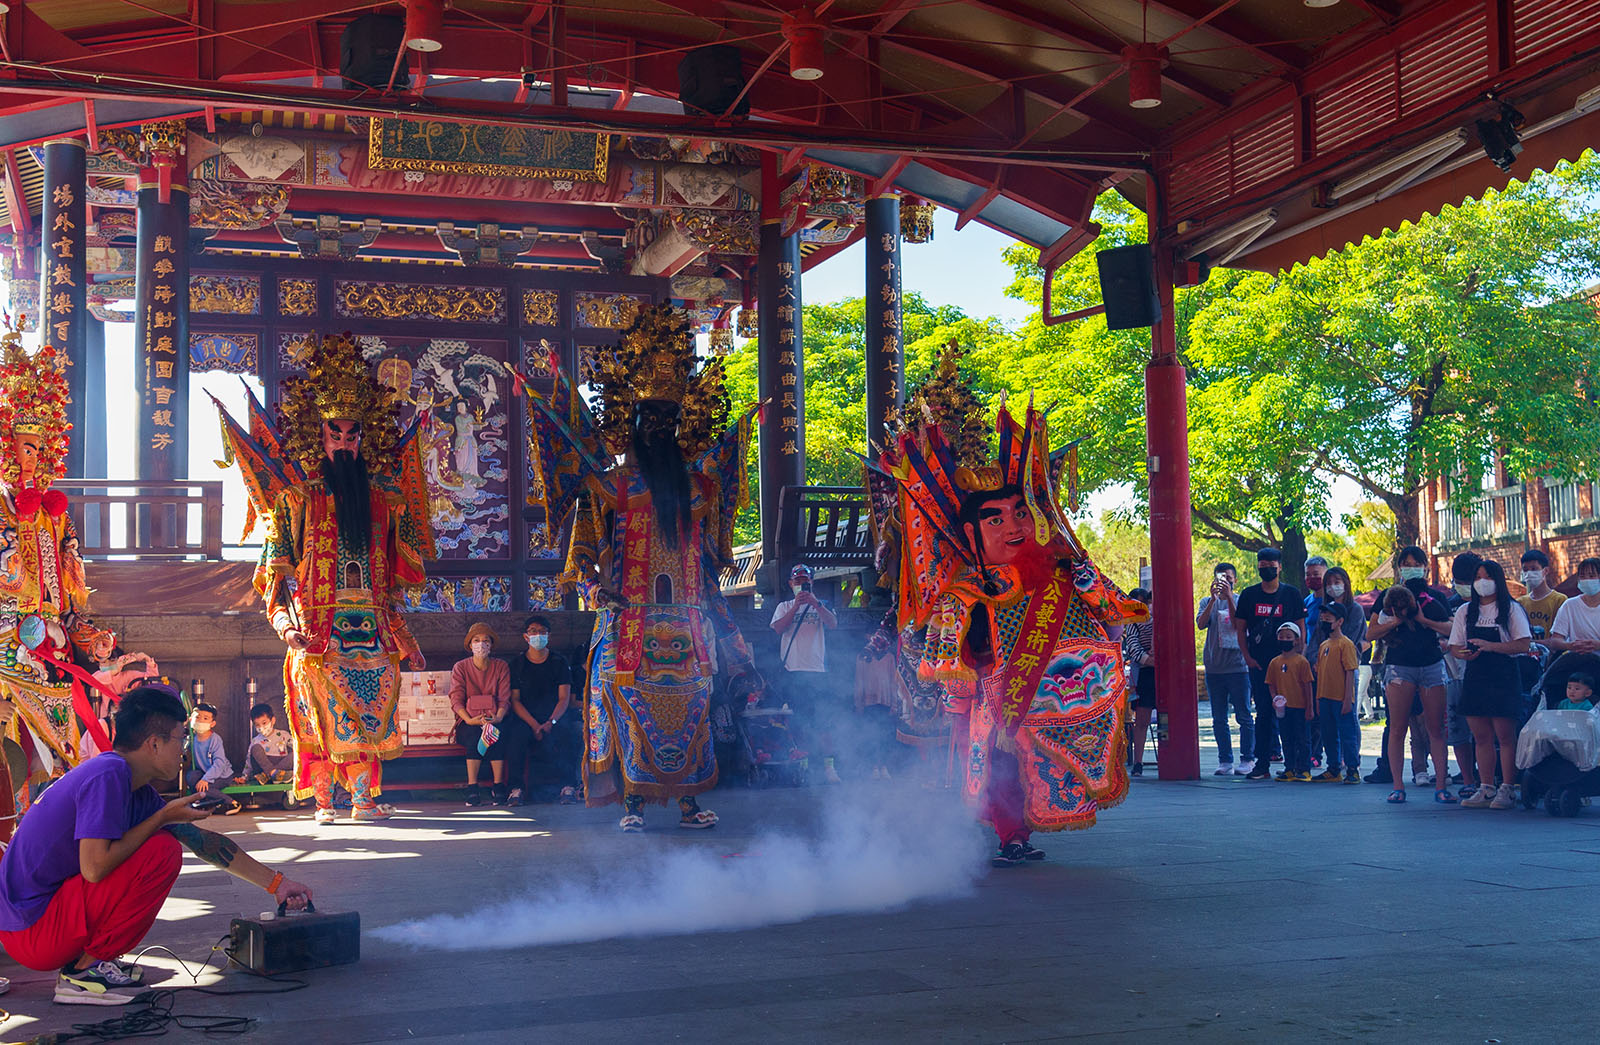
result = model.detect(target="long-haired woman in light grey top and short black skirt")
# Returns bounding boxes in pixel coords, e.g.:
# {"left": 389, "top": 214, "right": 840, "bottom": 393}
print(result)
{"left": 1450, "top": 559, "right": 1533, "bottom": 810}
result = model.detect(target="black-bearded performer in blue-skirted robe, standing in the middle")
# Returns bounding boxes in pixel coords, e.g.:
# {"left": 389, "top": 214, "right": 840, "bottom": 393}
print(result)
{"left": 517, "top": 304, "right": 755, "bottom": 831}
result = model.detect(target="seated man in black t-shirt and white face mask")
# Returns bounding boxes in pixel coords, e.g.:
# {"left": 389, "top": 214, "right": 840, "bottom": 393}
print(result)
{"left": 501, "top": 615, "right": 582, "bottom": 805}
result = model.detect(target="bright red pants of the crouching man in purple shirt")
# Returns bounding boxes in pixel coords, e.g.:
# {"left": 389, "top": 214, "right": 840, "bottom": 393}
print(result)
{"left": 0, "top": 831, "right": 184, "bottom": 971}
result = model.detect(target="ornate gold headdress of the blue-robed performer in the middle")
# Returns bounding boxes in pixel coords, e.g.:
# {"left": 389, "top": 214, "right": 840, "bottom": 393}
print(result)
{"left": 594, "top": 297, "right": 730, "bottom": 458}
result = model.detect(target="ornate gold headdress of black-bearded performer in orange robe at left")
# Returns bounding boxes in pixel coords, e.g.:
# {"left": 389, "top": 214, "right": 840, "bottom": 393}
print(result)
{"left": 278, "top": 334, "right": 400, "bottom": 475}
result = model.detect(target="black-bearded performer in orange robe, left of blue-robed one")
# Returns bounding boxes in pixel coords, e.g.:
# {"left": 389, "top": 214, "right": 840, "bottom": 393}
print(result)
{"left": 218, "top": 336, "right": 434, "bottom": 824}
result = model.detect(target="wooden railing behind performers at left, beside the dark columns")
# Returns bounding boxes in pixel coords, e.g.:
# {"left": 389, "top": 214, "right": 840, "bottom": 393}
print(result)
{"left": 54, "top": 478, "right": 222, "bottom": 559}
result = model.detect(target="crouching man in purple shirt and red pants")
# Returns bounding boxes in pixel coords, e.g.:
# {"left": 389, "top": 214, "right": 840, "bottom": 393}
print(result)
{"left": 0, "top": 685, "right": 310, "bottom": 1005}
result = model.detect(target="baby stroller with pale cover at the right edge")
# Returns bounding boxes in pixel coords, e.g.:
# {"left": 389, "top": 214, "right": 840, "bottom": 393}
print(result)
{"left": 1517, "top": 653, "right": 1600, "bottom": 816}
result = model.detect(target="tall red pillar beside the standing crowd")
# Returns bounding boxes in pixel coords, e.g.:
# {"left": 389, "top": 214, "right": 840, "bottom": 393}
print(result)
{"left": 1144, "top": 230, "right": 1200, "bottom": 779}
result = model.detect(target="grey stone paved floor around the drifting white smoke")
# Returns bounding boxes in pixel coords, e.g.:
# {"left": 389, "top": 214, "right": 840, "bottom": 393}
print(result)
{"left": 0, "top": 709, "right": 1600, "bottom": 1045}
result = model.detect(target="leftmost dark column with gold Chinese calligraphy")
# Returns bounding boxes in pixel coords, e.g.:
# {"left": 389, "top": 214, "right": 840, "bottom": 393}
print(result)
{"left": 38, "top": 138, "right": 88, "bottom": 478}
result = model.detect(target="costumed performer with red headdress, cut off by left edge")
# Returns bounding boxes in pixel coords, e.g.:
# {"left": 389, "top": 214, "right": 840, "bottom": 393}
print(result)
{"left": 0, "top": 320, "right": 110, "bottom": 840}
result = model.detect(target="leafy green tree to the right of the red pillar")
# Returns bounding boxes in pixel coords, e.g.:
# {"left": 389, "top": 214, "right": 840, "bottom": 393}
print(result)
{"left": 1189, "top": 152, "right": 1600, "bottom": 544}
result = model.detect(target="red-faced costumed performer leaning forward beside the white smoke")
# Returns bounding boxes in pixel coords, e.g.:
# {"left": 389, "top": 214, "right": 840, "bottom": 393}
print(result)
{"left": 883, "top": 344, "right": 1146, "bottom": 866}
